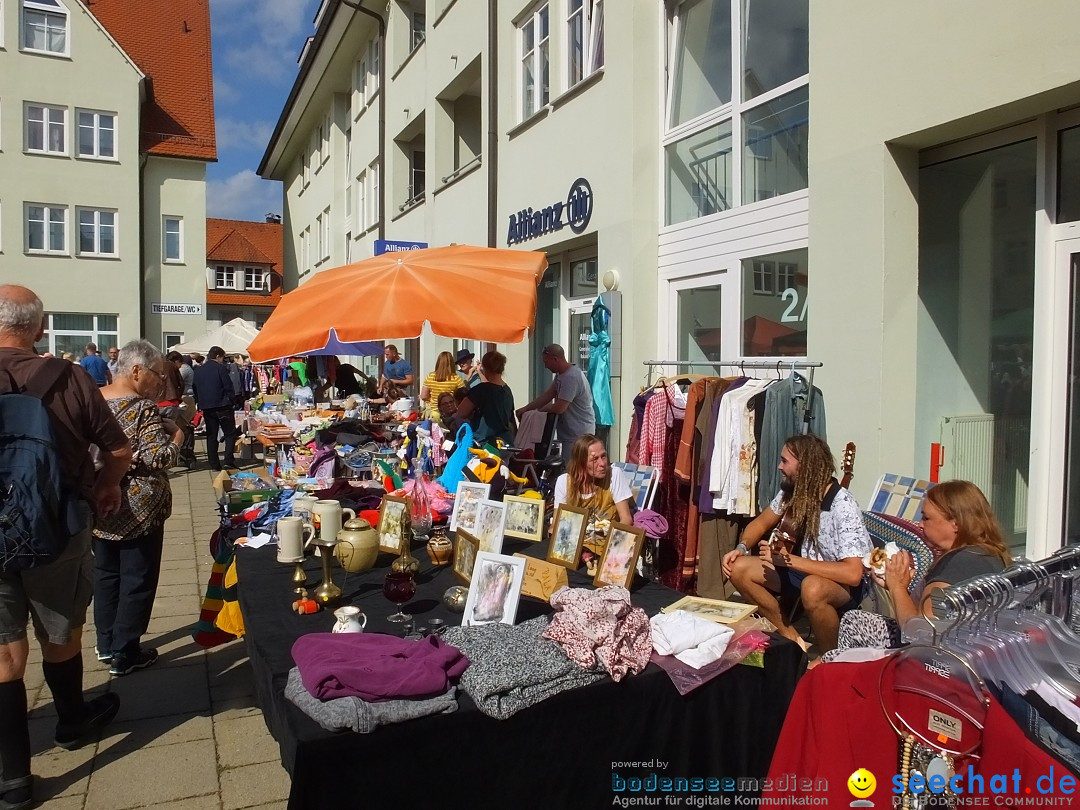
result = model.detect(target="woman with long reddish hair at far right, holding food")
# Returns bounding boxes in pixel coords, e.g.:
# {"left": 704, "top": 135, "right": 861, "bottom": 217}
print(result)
{"left": 885, "top": 481, "right": 1012, "bottom": 626}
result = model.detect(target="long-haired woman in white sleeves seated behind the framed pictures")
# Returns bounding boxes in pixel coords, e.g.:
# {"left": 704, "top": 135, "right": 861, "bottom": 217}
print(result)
{"left": 555, "top": 434, "right": 633, "bottom": 524}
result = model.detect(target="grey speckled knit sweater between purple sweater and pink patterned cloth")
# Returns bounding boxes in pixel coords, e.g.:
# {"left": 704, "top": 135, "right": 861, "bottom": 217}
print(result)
{"left": 443, "top": 616, "right": 604, "bottom": 720}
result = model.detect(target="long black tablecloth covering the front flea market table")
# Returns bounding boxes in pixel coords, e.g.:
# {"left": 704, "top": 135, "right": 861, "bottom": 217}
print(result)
{"left": 237, "top": 540, "right": 806, "bottom": 810}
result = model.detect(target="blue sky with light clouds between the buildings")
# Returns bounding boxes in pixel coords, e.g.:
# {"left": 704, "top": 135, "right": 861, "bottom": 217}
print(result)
{"left": 206, "top": 0, "right": 319, "bottom": 221}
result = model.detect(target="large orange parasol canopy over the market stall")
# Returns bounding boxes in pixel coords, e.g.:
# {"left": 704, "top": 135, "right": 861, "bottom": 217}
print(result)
{"left": 247, "top": 245, "right": 548, "bottom": 363}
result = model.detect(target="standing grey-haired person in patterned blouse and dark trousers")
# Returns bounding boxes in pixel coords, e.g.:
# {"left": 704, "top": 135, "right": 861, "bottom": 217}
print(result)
{"left": 94, "top": 340, "right": 184, "bottom": 676}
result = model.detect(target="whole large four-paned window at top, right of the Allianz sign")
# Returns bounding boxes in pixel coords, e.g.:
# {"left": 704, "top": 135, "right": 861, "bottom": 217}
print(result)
{"left": 664, "top": 0, "right": 810, "bottom": 225}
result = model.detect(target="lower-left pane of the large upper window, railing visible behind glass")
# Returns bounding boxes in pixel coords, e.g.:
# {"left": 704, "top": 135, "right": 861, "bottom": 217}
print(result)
{"left": 664, "top": 121, "right": 733, "bottom": 225}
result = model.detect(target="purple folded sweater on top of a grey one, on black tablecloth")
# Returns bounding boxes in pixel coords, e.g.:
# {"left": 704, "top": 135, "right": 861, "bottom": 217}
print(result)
{"left": 293, "top": 633, "right": 469, "bottom": 701}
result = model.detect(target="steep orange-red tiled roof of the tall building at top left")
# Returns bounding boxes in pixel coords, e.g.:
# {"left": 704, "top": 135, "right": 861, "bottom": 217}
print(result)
{"left": 84, "top": 0, "right": 217, "bottom": 161}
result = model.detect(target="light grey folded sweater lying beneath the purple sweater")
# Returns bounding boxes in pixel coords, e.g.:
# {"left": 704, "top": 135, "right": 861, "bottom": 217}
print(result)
{"left": 285, "top": 666, "right": 458, "bottom": 734}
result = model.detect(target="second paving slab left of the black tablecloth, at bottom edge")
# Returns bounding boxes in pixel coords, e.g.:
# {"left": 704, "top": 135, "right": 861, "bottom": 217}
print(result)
{"left": 86, "top": 740, "right": 219, "bottom": 810}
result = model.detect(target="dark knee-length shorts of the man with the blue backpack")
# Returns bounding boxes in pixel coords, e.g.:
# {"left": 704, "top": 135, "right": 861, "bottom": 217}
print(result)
{"left": 0, "top": 503, "right": 94, "bottom": 644}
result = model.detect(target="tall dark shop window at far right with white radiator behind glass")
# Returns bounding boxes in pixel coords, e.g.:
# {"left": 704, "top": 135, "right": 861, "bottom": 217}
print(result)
{"left": 915, "top": 139, "right": 1036, "bottom": 549}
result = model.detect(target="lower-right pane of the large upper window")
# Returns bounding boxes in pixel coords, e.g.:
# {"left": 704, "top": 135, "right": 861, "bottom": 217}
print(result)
{"left": 743, "top": 87, "right": 810, "bottom": 203}
